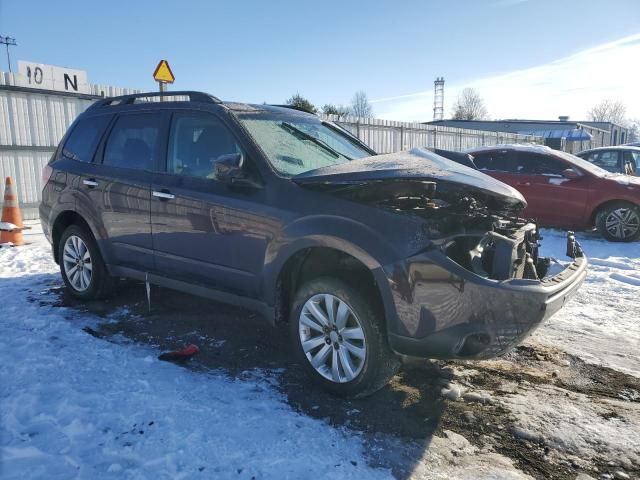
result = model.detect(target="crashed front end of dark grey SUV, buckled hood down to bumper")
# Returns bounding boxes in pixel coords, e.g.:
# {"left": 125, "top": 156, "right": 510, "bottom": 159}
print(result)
{"left": 295, "top": 149, "right": 588, "bottom": 359}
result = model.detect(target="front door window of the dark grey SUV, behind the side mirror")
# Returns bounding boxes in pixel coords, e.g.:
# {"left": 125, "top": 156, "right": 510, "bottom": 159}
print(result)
{"left": 167, "top": 113, "right": 242, "bottom": 180}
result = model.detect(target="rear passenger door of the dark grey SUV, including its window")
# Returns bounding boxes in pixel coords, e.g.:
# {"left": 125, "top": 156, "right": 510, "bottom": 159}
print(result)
{"left": 90, "top": 112, "right": 167, "bottom": 271}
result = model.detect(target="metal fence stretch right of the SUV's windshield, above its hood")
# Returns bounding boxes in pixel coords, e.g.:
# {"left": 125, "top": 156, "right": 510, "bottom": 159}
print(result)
{"left": 320, "top": 115, "right": 542, "bottom": 153}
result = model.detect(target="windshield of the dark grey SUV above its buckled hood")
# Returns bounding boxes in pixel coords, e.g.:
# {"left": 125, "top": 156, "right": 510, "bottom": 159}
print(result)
{"left": 238, "top": 115, "right": 371, "bottom": 176}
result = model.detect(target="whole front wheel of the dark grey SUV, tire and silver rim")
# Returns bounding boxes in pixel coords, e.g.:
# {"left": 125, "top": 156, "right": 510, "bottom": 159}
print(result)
{"left": 289, "top": 277, "right": 400, "bottom": 397}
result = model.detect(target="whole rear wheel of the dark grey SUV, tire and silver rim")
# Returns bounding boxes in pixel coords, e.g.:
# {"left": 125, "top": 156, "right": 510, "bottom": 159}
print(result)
{"left": 58, "top": 225, "right": 115, "bottom": 300}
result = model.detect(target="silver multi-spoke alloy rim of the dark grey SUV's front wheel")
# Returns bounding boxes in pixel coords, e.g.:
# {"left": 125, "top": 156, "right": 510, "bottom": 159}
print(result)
{"left": 298, "top": 293, "right": 367, "bottom": 383}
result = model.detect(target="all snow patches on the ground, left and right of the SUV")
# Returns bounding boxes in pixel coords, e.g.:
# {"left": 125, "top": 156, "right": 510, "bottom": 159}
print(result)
{"left": 0, "top": 226, "right": 640, "bottom": 479}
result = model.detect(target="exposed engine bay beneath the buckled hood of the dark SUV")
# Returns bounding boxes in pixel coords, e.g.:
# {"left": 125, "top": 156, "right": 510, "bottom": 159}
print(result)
{"left": 300, "top": 179, "right": 581, "bottom": 280}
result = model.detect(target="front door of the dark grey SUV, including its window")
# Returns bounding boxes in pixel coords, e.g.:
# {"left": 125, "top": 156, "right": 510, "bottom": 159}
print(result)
{"left": 151, "top": 112, "right": 270, "bottom": 297}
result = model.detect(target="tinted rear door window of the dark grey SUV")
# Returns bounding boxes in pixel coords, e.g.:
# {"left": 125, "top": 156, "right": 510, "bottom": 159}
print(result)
{"left": 102, "top": 113, "right": 163, "bottom": 170}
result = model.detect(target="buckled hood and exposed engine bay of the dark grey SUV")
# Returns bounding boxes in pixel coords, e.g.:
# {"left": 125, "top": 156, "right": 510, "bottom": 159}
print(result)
{"left": 294, "top": 148, "right": 582, "bottom": 281}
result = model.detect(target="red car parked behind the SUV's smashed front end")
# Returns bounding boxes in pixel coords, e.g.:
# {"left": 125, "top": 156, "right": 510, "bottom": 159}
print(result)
{"left": 467, "top": 145, "right": 640, "bottom": 242}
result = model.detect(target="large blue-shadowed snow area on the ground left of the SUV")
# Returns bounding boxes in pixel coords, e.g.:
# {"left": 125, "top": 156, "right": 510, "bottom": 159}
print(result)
{"left": 0, "top": 226, "right": 396, "bottom": 480}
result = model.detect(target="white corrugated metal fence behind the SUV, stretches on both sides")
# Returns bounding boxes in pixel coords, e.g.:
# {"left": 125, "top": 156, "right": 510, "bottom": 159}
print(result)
{"left": 0, "top": 72, "right": 541, "bottom": 218}
